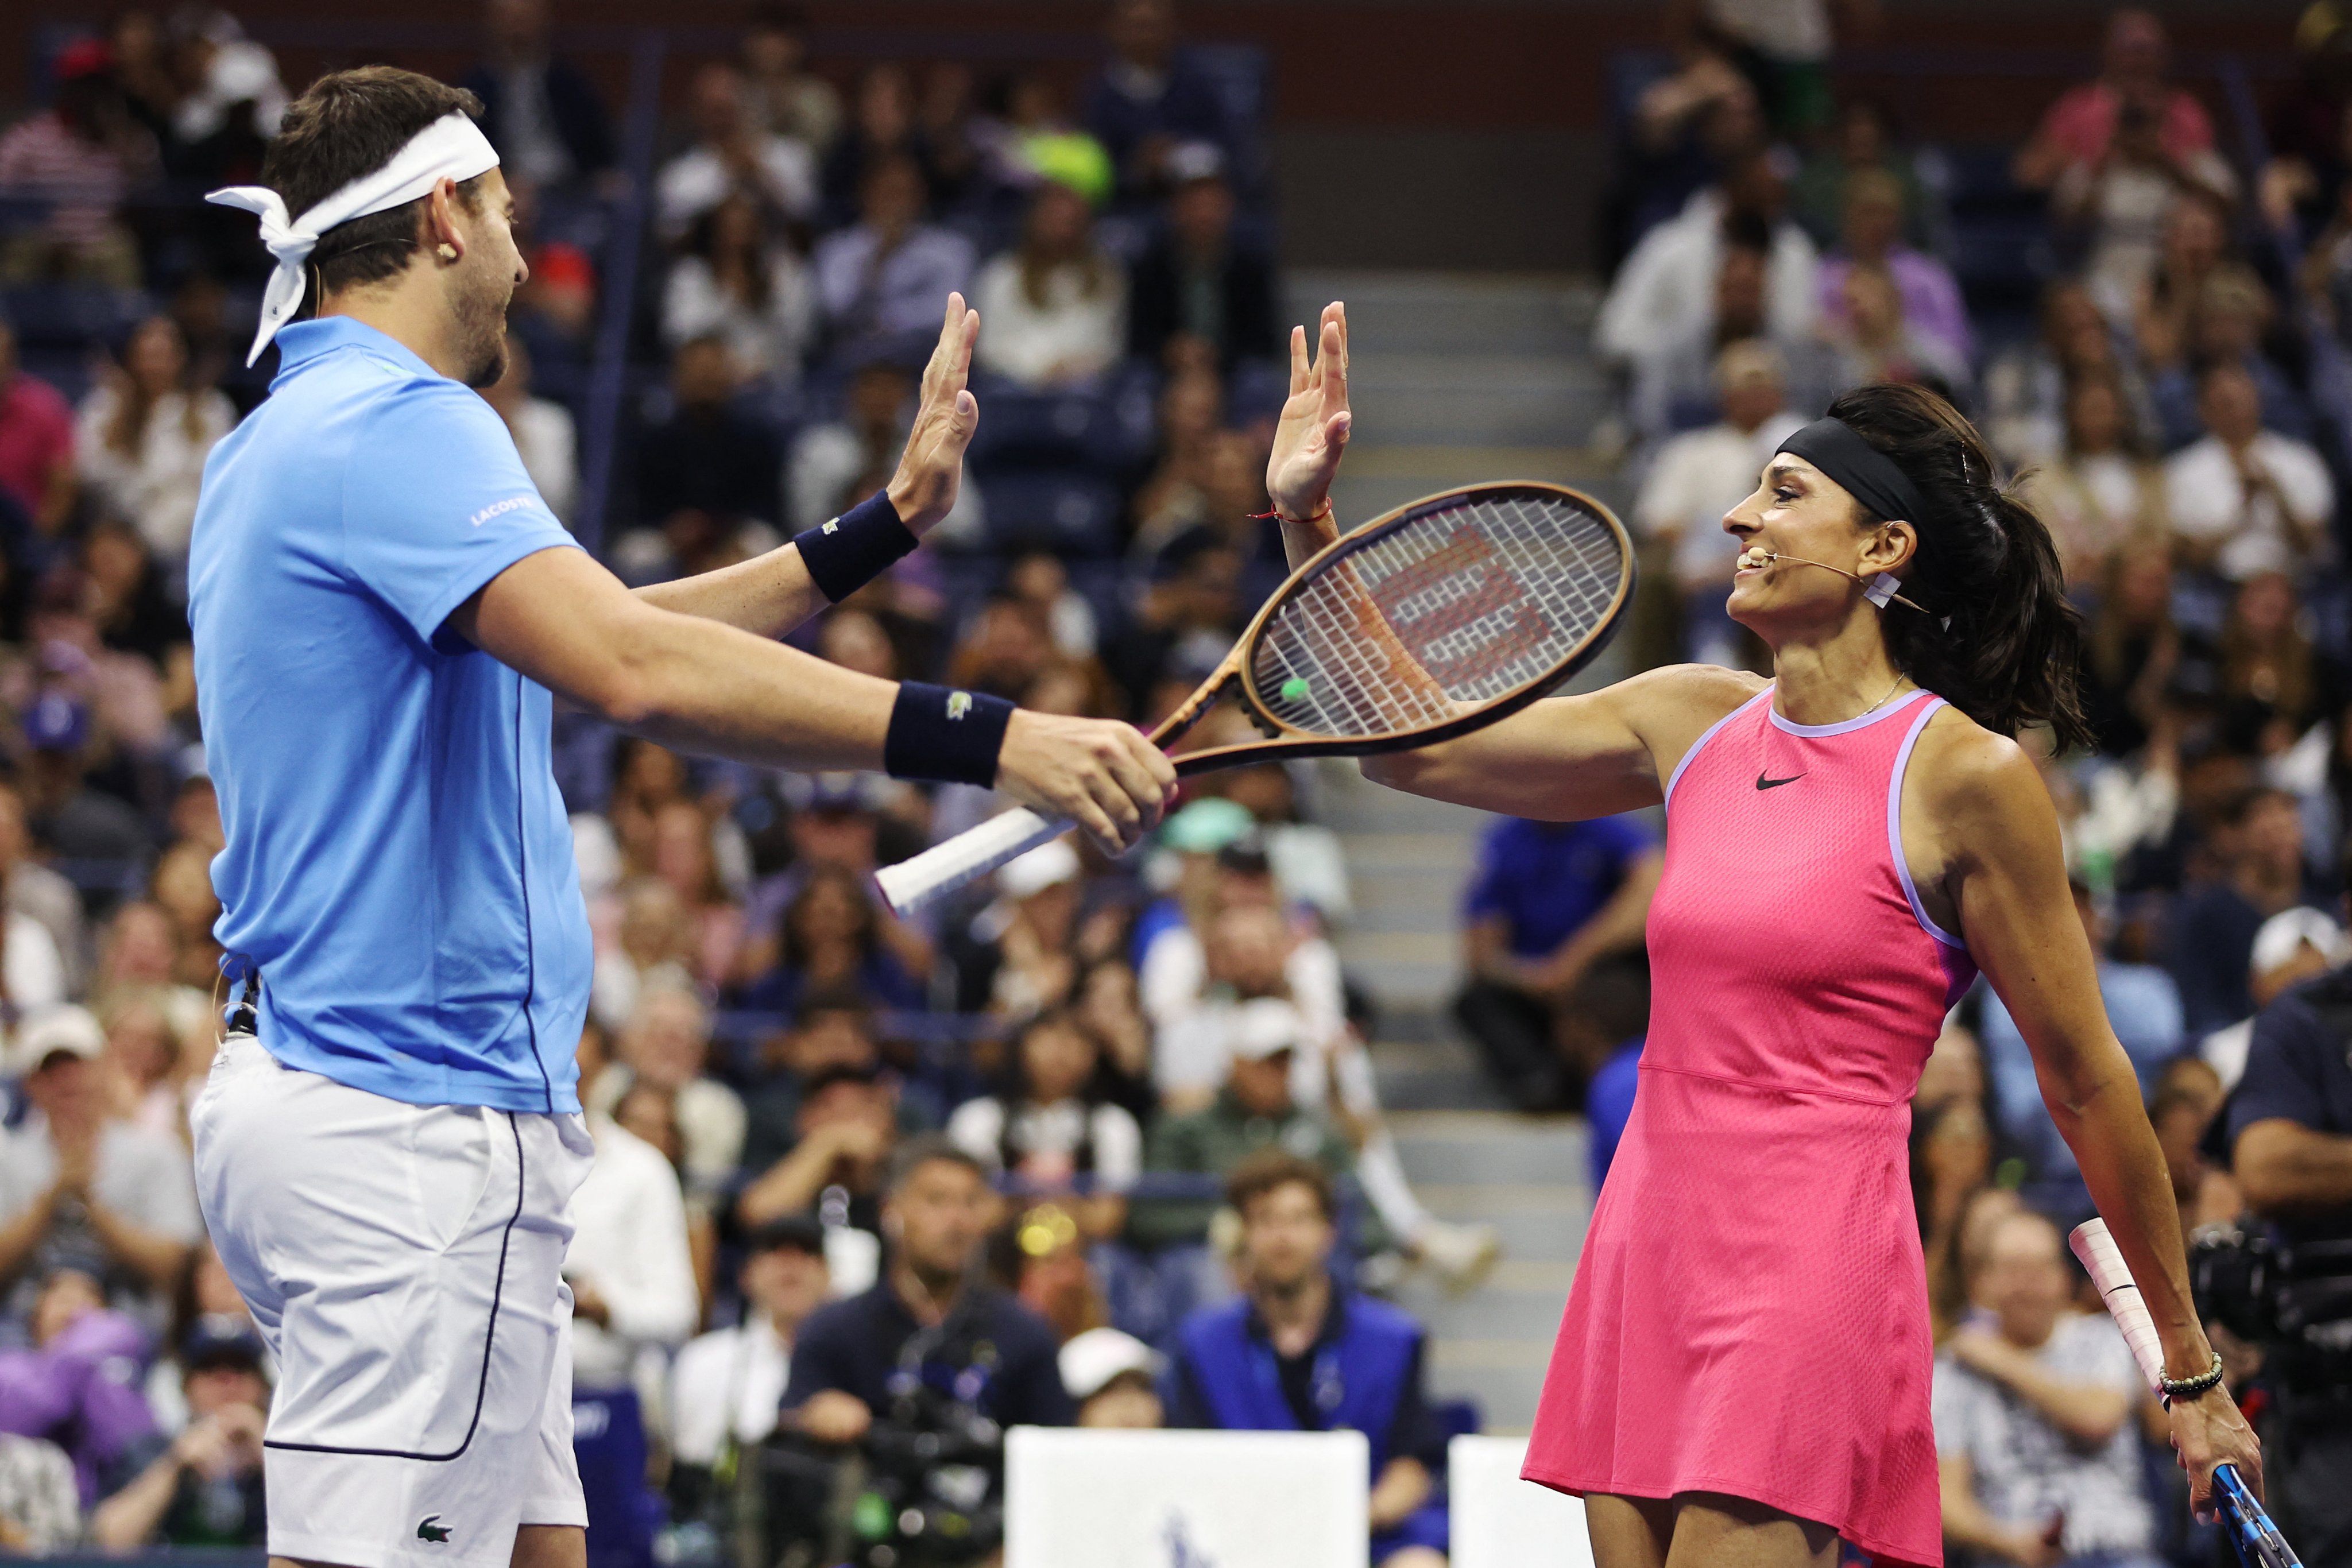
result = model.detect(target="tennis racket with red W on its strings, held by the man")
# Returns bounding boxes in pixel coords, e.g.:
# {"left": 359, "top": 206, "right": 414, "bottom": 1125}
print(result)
{"left": 875, "top": 482, "right": 1633, "bottom": 915}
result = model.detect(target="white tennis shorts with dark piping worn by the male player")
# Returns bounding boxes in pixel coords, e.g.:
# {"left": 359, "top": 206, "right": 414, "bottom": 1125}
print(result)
{"left": 191, "top": 1035, "right": 595, "bottom": 1568}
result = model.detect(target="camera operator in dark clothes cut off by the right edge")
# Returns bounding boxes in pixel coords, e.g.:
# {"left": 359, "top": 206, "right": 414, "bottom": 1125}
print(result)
{"left": 2197, "top": 966, "right": 2352, "bottom": 1568}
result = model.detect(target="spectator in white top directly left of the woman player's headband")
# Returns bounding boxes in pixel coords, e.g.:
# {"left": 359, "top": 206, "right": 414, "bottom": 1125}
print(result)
{"left": 1633, "top": 339, "right": 1804, "bottom": 668}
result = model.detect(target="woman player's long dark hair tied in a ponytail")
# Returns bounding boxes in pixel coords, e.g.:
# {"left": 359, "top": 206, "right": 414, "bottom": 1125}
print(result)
{"left": 1830, "top": 385, "right": 2093, "bottom": 752}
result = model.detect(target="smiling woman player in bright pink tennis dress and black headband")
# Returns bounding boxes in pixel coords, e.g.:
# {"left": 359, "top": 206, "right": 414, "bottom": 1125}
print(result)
{"left": 1268, "top": 305, "right": 2260, "bottom": 1568}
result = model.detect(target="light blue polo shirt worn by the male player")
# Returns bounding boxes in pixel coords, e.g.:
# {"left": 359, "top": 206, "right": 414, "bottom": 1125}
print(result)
{"left": 188, "top": 318, "right": 593, "bottom": 1112}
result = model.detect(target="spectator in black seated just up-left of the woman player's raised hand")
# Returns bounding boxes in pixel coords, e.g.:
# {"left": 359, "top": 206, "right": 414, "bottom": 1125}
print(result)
{"left": 1124, "top": 139, "right": 1282, "bottom": 369}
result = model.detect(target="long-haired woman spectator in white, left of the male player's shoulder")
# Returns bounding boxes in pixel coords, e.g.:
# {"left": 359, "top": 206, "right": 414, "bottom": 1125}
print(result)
{"left": 73, "top": 315, "right": 238, "bottom": 567}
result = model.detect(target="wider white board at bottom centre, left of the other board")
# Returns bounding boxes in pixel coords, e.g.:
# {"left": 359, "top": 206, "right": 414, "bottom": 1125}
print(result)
{"left": 1004, "top": 1427, "right": 1371, "bottom": 1568}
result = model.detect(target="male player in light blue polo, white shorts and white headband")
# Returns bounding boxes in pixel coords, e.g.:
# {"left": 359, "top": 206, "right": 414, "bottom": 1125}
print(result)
{"left": 191, "top": 68, "right": 1174, "bottom": 1568}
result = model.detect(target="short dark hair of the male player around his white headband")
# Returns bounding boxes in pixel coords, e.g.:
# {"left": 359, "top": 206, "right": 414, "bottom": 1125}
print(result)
{"left": 261, "top": 66, "right": 482, "bottom": 305}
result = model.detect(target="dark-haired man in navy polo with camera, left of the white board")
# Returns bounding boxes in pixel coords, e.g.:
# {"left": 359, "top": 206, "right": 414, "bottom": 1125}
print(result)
{"left": 783, "top": 1138, "right": 1075, "bottom": 1563}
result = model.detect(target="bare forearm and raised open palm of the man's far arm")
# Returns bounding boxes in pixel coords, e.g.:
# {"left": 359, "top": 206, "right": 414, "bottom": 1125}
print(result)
{"left": 637, "top": 294, "right": 981, "bottom": 637}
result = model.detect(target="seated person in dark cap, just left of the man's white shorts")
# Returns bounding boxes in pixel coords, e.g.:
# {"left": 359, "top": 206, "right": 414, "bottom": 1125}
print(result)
{"left": 90, "top": 1326, "right": 270, "bottom": 1551}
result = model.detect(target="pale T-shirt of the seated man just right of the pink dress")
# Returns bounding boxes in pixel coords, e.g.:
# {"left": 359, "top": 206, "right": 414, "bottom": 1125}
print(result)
{"left": 1933, "top": 1312, "right": 2154, "bottom": 1559}
